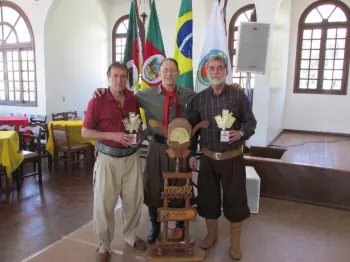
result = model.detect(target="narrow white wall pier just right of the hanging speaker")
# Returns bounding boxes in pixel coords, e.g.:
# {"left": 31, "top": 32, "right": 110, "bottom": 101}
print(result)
{"left": 266, "top": 0, "right": 292, "bottom": 144}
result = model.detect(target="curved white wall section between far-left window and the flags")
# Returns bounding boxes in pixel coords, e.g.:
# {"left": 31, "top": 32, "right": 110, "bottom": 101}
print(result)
{"left": 45, "top": 0, "right": 109, "bottom": 119}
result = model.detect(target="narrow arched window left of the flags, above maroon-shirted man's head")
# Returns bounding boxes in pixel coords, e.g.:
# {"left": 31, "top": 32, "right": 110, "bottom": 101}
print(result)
{"left": 112, "top": 15, "right": 129, "bottom": 62}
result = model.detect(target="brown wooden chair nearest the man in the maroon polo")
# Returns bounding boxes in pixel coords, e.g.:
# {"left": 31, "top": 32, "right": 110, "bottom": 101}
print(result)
{"left": 51, "top": 125, "right": 92, "bottom": 177}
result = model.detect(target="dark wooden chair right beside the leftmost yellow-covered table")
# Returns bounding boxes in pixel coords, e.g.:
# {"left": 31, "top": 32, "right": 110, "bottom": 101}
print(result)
{"left": 17, "top": 126, "right": 42, "bottom": 190}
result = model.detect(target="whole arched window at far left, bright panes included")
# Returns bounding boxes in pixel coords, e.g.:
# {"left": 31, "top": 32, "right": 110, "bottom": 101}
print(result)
{"left": 0, "top": 1, "right": 37, "bottom": 106}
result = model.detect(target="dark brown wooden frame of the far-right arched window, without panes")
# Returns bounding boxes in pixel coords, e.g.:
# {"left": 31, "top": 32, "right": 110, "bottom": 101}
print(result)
{"left": 293, "top": 0, "right": 350, "bottom": 95}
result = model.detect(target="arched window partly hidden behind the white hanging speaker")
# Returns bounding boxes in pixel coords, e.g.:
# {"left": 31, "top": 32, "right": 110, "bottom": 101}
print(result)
{"left": 229, "top": 4, "right": 256, "bottom": 88}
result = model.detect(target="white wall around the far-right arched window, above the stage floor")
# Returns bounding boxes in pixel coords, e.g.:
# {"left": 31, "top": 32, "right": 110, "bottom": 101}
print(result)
{"left": 284, "top": 0, "right": 350, "bottom": 134}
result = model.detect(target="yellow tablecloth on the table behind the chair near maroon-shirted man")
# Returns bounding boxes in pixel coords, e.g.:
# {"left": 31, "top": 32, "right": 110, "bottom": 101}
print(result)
{"left": 46, "top": 120, "right": 95, "bottom": 155}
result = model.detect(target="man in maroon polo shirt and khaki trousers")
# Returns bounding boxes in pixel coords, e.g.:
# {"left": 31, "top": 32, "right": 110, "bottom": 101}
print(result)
{"left": 82, "top": 62, "right": 147, "bottom": 262}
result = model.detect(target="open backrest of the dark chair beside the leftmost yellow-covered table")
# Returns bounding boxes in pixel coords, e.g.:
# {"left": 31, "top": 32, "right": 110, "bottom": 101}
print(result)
{"left": 18, "top": 126, "right": 41, "bottom": 153}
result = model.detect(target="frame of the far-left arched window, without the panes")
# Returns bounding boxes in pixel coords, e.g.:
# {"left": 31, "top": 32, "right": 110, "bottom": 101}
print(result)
{"left": 0, "top": 1, "right": 38, "bottom": 107}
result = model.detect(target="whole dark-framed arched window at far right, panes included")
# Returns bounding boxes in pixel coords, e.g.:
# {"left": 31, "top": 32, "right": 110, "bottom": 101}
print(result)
{"left": 294, "top": 1, "right": 350, "bottom": 95}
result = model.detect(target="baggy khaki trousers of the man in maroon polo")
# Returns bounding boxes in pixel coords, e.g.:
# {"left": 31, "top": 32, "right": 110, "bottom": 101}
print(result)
{"left": 93, "top": 151, "right": 143, "bottom": 252}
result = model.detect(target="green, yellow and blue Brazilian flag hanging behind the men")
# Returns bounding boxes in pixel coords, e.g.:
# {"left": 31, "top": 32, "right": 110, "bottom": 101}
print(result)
{"left": 174, "top": 0, "right": 193, "bottom": 90}
